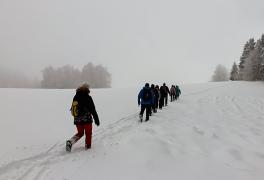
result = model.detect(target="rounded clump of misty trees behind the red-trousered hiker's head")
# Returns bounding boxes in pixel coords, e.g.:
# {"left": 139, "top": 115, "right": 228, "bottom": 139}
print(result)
{"left": 41, "top": 63, "right": 111, "bottom": 89}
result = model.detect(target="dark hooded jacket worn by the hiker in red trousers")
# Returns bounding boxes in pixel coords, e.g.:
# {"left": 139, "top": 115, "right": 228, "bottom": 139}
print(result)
{"left": 73, "top": 88, "right": 100, "bottom": 125}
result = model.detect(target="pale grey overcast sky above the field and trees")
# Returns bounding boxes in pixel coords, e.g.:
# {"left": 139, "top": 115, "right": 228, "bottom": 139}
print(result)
{"left": 0, "top": 0, "right": 264, "bottom": 87}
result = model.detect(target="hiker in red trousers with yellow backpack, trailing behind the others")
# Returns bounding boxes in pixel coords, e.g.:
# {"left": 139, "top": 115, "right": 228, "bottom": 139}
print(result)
{"left": 66, "top": 83, "right": 100, "bottom": 152}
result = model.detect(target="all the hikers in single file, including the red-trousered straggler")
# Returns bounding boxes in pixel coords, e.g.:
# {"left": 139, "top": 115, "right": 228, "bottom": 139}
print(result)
{"left": 66, "top": 83, "right": 181, "bottom": 152}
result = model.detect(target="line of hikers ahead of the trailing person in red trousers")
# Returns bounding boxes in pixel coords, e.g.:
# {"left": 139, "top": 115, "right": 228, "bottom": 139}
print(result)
{"left": 138, "top": 83, "right": 181, "bottom": 122}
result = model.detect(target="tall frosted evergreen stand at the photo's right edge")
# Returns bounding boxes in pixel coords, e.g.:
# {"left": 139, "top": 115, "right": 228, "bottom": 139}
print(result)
{"left": 230, "top": 34, "right": 264, "bottom": 81}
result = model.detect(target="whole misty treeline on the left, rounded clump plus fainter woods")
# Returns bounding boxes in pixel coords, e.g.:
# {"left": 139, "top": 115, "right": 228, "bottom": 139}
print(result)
{"left": 0, "top": 63, "right": 111, "bottom": 89}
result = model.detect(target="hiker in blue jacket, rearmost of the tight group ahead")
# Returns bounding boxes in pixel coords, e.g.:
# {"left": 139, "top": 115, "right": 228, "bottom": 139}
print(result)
{"left": 138, "top": 83, "right": 154, "bottom": 122}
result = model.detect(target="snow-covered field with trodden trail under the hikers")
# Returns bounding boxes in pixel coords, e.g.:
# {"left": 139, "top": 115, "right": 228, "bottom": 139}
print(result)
{"left": 0, "top": 82, "right": 264, "bottom": 180}
